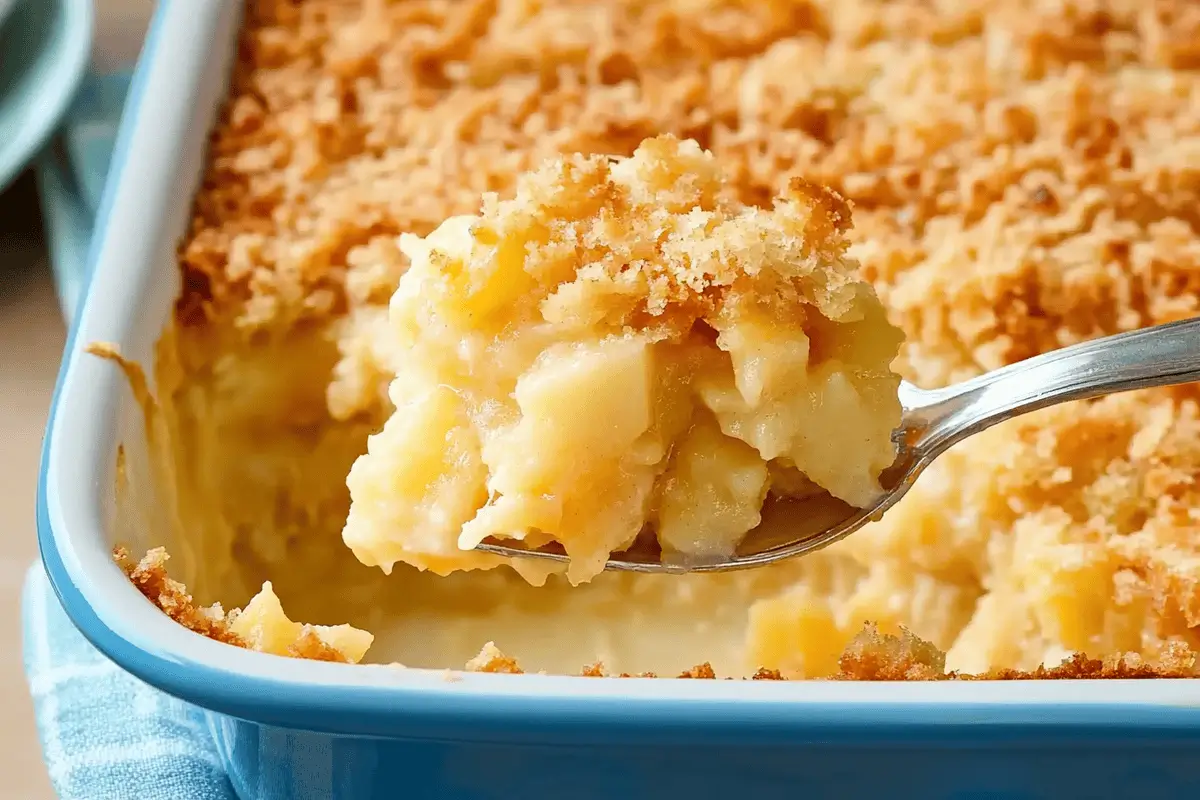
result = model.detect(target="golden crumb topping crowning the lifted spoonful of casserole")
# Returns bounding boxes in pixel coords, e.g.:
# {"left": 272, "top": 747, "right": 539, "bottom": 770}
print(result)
{"left": 392, "top": 136, "right": 878, "bottom": 345}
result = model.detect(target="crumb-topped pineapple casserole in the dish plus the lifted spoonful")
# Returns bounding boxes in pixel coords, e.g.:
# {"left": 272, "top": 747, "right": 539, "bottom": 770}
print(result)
{"left": 112, "top": 0, "right": 1200, "bottom": 679}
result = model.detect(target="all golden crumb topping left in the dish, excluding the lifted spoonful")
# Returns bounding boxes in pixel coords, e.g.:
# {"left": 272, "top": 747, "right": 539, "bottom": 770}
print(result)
{"left": 157, "top": 0, "right": 1200, "bottom": 679}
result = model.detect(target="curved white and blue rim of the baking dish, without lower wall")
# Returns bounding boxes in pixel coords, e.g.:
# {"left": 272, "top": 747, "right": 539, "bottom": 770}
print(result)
{"left": 30, "top": 0, "right": 1200, "bottom": 744}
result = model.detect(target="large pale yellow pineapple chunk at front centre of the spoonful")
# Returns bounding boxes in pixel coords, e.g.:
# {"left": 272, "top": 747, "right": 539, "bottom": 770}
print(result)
{"left": 457, "top": 337, "right": 661, "bottom": 575}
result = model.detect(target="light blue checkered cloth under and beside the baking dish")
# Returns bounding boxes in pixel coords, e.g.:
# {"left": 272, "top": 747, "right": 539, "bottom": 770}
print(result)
{"left": 22, "top": 74, "right": 236, "bottom": 800}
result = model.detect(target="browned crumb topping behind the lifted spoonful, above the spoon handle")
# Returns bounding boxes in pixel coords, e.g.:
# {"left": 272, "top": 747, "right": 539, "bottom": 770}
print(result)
{"left": 181, "top": 0, "right": 1200, "bottom": 384}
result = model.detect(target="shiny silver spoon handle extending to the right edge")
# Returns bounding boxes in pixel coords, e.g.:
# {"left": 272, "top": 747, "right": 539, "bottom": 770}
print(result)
{"left": 908, "top": 318, "right": 1200, "bottom": 458}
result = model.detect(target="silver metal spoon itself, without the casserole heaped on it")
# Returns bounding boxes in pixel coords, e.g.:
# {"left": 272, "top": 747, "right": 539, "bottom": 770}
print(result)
{"left": 476, "top": 318, "right": 1200, "bottom": 573}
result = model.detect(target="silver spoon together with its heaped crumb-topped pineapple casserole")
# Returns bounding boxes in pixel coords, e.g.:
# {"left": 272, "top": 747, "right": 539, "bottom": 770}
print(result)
{"left": 343, "top": 137, "right": 1200, "bottom": 583}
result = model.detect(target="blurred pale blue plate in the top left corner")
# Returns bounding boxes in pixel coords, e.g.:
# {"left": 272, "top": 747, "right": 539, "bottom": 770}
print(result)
{"left": 0, "top": 0, "right": 92, "bottom": 196}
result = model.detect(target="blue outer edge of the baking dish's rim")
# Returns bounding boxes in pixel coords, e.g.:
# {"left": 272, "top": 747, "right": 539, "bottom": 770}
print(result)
{"left": 37, "top": 4, "right": 1200, "bottom": 748}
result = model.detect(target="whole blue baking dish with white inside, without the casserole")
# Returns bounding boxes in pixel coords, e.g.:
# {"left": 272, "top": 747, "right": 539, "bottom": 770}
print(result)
{"left": 37, "top": 0, "right": 1200, "bottom": 800}
